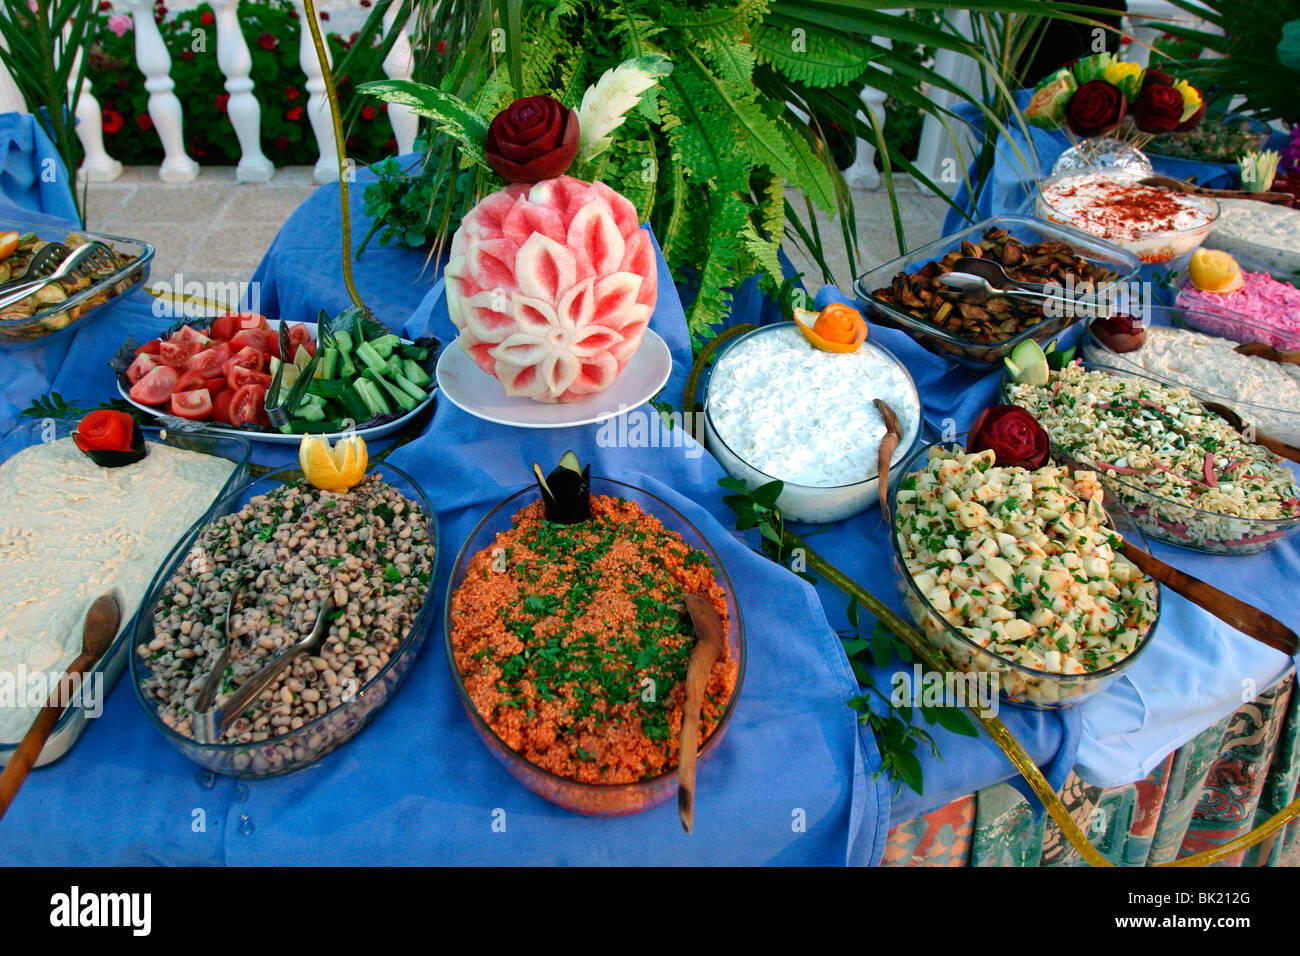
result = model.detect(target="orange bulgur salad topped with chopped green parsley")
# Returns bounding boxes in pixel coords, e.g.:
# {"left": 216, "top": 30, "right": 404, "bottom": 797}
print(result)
{"left": 449, "top": 494, "right": 738, "bottom": 784}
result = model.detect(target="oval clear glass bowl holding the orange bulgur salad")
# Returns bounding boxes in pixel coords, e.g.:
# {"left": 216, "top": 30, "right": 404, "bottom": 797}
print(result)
{"left": 443, "top": 476, "right": 746, "bottom": 817}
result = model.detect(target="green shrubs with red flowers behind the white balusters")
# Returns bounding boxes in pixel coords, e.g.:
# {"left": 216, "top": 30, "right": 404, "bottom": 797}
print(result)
{"left": 88, "top": 0, "right": 410, "bottom": 165}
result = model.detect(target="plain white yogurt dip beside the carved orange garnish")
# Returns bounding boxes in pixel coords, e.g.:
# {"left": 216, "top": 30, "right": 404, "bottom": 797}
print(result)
{"left": 706, "top": 324, "right": 920, "bottom": 522}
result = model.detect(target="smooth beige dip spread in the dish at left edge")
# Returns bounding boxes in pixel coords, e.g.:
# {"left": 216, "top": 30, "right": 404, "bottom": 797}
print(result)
{"left": 0, "top": 438, "right": 235, "bottom": 744}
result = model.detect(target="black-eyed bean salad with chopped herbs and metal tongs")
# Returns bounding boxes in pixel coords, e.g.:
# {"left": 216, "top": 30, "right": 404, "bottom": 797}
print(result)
{"left": 137, "top": 472, "right": 434, "bottom": 749}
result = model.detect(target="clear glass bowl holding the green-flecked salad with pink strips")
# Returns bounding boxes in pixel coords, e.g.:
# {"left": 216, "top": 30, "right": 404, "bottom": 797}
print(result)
{"left": 1001, "top": 362, "right": 1300, "bottom": 554}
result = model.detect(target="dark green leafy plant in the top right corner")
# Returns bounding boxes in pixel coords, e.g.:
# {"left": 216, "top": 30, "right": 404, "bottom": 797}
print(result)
{"left": 1165, "top": 0, "right": 1300, "bottom": 125}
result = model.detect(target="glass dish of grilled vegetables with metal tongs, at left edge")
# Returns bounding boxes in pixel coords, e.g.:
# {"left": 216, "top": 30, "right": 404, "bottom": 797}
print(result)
{"left": 0, "top": 230, "right": 153, "bottom": 346}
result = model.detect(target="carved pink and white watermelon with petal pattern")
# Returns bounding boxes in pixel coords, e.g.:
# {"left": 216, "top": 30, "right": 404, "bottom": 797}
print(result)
{"left": 443, "top": 176, "right": 658, "bottom": 402}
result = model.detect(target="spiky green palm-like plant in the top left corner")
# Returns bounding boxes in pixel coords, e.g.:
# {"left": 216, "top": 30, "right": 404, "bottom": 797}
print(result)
{"left": 0, "top": 0, "right": 94, "bottom": 225}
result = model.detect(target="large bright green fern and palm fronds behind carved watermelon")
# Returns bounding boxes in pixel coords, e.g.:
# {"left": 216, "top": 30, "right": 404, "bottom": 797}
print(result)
{"left": 372, "top": 0, "right": 1097, "bottom": 345}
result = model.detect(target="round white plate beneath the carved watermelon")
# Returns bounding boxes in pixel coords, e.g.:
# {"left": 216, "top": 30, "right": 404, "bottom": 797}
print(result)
{"left": 437, "top": 329, "right": 672, "bottom": 428}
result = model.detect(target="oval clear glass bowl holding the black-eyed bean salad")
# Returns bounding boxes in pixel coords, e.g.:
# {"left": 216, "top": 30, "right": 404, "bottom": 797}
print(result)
{"left": 130, "top": 462, "right": 441, "bottom": 777}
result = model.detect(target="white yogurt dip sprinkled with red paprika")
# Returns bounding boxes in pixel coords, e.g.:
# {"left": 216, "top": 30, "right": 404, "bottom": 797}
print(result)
{"left": 1037, "top": 173, "right": 1218, "bottom": 263}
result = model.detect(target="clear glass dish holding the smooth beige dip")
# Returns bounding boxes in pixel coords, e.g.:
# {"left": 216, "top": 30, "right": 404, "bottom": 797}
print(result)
{"left": 0, "top": 419, "right": 252, "bottom": 767}
